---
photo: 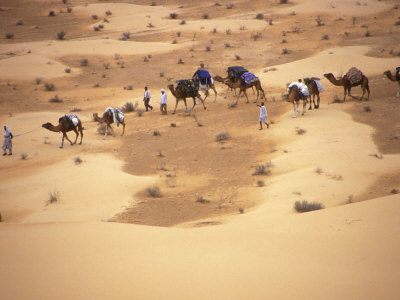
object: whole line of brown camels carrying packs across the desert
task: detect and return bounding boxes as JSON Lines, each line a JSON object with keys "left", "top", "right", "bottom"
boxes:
{"left": 38, "top": 66, "right": 400, "bottom": 148}
